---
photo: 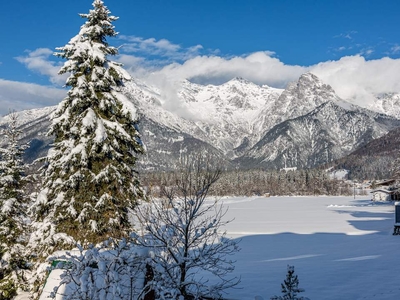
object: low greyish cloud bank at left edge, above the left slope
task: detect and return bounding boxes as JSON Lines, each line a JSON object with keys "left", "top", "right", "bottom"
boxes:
{"left": 0, "top": 79, "right": 66, "bottom": 116}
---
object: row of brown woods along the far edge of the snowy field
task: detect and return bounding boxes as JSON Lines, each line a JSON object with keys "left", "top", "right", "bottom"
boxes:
{"left": 140, "top": 169, "right": 354, "bottom": 197}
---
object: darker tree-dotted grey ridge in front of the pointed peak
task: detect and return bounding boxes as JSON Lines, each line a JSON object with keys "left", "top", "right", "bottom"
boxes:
{"left": 238, "top": 101, "right": 400, "bottom": 168}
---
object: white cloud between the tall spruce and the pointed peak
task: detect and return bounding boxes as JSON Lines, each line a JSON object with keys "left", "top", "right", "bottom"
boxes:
{"left": 124, "top": 51, "right": 307, "bottom": 119}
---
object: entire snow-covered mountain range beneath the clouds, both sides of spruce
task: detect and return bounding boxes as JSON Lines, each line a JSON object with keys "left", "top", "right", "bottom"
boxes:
{"left": 0, "top": 73, "right": 400, "bottom": 170}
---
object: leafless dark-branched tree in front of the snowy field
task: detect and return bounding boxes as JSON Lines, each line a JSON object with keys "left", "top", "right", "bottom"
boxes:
{"left": 134, "top": 154, "right": 239, "bottom": 299}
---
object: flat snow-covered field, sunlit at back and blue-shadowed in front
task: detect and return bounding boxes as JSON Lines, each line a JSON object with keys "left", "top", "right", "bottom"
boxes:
{"left": 217, "top": 196, "right": 400, "bottom": 300}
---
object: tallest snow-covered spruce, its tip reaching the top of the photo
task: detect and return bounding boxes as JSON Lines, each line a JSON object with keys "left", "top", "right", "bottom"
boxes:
{"left": 33, "top": 0, "right": 143, "bottom": 256}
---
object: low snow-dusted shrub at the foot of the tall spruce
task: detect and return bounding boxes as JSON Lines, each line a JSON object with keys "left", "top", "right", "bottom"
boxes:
{"left": 50, "top": 239, "right": 145, "bottom": 300}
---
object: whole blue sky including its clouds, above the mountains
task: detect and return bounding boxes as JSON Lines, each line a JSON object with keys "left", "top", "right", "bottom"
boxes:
{"left": 0, "top": 0, "right": 400, "bottom": 113}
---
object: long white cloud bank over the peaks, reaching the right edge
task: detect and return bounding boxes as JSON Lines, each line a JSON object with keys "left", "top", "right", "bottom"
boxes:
{"left": 135, "top": 52, "right": 400, "bottom": 114}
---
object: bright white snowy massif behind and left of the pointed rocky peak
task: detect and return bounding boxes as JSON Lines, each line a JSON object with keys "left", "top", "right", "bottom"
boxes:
{"left": 126, "top": 78, "right": 282, "bottom": 158}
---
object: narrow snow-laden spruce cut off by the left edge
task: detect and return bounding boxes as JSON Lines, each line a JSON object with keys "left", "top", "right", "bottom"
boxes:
{"left": 0, "top": 113, "right": 28, "bottom": 299}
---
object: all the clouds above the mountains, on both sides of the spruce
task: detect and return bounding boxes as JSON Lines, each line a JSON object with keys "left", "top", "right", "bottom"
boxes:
{"left": 0, "top": 36, "right": 400, "bottom": 115}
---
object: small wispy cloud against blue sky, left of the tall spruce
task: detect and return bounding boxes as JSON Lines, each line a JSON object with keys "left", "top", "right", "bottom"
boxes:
{"left": 15, "top": 48, "right": 68, "bottom": 85}
